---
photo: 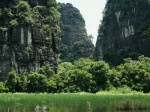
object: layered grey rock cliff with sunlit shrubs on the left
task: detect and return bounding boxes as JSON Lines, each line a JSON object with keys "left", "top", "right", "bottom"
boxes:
{"left": 0, "top": 0, "right": 60, "bottom": 80}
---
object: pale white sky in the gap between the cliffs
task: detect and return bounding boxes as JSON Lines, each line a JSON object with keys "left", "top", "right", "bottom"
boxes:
{"left": 56, "top": 0, "right": 106, "bottom": 44}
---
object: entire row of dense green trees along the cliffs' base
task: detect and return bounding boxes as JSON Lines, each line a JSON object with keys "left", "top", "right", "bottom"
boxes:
{"left": 0, "top": 56, "right": 150, "bottom": 93}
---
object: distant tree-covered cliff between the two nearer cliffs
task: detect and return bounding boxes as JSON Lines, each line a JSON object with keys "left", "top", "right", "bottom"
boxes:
{"left": 58, "top": 3, "right": 94, "bottom": 62}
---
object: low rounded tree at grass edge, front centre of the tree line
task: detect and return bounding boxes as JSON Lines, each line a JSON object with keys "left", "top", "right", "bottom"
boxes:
{"left": 68, "top": 69, "right": 96, "bottom": 92}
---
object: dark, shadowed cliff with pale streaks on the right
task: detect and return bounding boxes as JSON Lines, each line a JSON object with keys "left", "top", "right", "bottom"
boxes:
{"left": 94, "top": 0, "right": 150, "bottom": 64}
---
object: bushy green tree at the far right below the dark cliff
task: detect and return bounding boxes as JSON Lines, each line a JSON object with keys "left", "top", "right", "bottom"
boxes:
{"left": 117, "top": 56, "right": 150, "bottom": 92}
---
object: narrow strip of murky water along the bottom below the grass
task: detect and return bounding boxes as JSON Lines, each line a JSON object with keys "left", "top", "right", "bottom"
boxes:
{"left": 0, "top": 106, "right": 150, "bottom": 112}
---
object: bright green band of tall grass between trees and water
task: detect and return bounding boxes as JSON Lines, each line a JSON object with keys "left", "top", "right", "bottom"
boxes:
{"left": 0, "top": 93, "right": 150, "bottom": 112}
